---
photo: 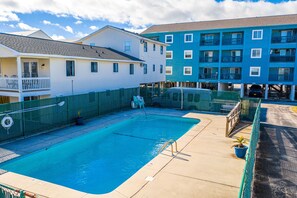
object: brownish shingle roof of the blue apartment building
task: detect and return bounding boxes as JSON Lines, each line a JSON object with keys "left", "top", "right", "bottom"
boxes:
{"left": 142, "top": 14, "right": 297, "bottom": 34}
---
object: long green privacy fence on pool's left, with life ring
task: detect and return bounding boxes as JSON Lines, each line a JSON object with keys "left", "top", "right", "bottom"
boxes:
{"left": 0, "top": 88, "right": 138, "bottom": 142}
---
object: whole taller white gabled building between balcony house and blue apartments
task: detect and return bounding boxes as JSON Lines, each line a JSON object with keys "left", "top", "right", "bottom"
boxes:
{"left": 77, "top": 26, "right": 167, "bottom": 84}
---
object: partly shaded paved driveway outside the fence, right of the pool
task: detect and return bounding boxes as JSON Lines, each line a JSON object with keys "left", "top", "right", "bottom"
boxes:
{"left": 253, "top": 104, "right": 297, "bottom": 198}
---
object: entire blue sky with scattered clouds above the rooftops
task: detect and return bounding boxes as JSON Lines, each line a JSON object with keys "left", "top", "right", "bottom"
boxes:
{"left": 0, "top": 0, "right": 297, "bottom": 39}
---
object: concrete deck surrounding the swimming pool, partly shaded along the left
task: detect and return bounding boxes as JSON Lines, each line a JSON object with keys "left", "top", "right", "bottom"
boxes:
{"left": 0, "top": 108, "right": 251, "bottom": 198}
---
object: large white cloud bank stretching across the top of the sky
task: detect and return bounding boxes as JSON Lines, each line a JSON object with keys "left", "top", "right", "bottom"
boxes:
{"left": 0, "top": 0, "right": 297, "bottom": 30}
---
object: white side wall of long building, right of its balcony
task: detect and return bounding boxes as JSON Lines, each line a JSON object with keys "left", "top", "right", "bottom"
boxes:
{"left": 50, "top": 58, "right": 142, "bottom": 97}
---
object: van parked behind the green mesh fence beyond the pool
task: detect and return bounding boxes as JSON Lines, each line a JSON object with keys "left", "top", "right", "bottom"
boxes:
{"left": 152, "top": 87, "right": 212, "bottom": 111}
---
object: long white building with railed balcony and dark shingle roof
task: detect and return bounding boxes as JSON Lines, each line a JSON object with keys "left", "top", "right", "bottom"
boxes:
{"left": 0, "top": 33, "right": 165, "bottom": 103}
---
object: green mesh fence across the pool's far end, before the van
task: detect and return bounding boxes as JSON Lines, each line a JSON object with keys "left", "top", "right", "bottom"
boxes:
{"left": 140, "top": 87, "right": 240, "bottom": 113}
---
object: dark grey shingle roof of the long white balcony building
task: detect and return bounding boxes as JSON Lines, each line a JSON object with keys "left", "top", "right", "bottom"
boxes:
{"left": 0, "top": 33, "right": 142, "bottom": 61}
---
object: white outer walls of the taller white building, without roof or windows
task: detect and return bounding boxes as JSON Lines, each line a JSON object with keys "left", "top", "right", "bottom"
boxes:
{"left": 83, "top": 28, "right": 166, "bottom": 83}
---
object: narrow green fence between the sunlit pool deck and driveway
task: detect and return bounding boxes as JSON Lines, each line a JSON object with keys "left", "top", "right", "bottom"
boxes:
{"left": 238, "top": 101, "right": 261, "bottom": 198}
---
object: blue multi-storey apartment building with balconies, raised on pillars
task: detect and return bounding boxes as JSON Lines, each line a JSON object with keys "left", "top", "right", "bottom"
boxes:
{"left": 142, "top": 14, "right": 297, "bottom": 100}
